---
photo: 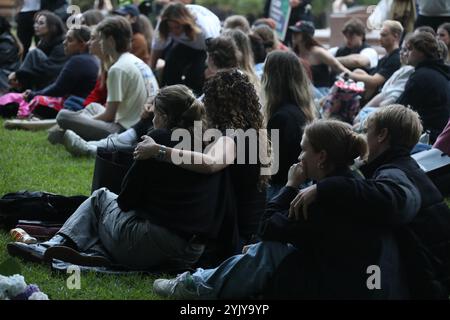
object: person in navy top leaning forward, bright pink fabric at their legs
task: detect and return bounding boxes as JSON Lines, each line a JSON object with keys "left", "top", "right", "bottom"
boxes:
{"left": 0, "top": 26, "right": 99, "bottom": 129}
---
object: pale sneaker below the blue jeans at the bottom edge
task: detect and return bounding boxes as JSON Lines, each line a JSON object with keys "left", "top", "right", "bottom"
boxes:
{"left": 153, "top": 271, "right": 200, "bottom": 300}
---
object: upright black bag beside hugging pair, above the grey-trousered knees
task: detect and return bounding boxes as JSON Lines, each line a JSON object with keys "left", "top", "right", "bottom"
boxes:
{"left": 92, "top": 148, "right": 134, "bottom": 194}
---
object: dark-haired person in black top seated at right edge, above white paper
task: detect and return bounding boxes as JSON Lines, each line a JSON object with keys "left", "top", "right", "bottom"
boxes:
{"left": 397, "top": 32, "right": 450, "bottom": 143}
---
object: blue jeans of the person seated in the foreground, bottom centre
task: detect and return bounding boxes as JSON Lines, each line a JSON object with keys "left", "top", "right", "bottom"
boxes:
{"left": 192, "top": 241, "right": 296, "bottom": 299}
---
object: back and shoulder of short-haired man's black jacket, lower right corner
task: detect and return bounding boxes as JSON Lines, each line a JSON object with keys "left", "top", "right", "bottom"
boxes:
{"left": 362, "top": 148, "right": 450, "bottom": 299}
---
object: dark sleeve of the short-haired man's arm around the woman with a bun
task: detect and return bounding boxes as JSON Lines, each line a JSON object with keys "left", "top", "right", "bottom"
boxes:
{"left": 317, "top": 168, "right": 421, "bottom": 225}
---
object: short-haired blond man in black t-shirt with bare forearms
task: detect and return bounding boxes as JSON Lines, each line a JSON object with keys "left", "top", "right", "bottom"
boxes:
{"left": 349, "top": 20, "right": 403, "bottom": 99}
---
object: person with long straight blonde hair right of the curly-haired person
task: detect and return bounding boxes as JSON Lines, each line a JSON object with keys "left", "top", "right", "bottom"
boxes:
{"left": 263, "top": 51, "right": 316, "bottom": 200}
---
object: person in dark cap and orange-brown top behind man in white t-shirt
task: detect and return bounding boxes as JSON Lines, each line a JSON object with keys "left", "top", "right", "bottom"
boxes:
{"left": 114, "top": 4, "right": 150, "bottom": 64}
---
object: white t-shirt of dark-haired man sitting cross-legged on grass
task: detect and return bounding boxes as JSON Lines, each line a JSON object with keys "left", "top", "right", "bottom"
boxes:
{"left": 106, "top": 52, "right": 158, "bottom": 129}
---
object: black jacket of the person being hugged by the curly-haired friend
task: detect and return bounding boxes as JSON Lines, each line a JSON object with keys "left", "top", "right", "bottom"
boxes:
{"left": 117, "top": 130, "right": 238, "bottom": 254}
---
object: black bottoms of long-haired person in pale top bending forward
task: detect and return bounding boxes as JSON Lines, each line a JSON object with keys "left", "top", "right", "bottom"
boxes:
{"left": 162, "top": 43, "right": 206, "bottom": 95}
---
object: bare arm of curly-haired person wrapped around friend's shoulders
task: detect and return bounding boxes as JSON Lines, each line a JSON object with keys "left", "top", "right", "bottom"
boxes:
{"left": 134, "top": 136, "right": 236, "bottom": 174}
